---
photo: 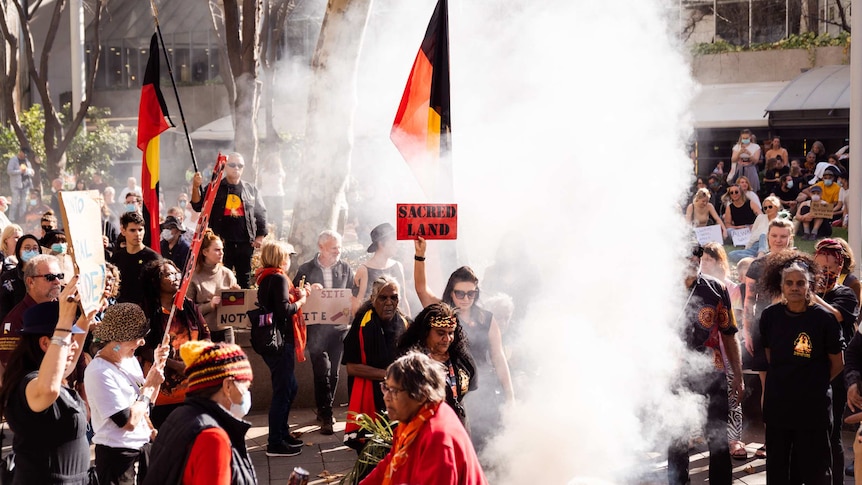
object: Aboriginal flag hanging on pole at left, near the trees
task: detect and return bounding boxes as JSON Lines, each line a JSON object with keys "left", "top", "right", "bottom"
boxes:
{"left": 138, "top": 34, "right": 170, "bottom": 246}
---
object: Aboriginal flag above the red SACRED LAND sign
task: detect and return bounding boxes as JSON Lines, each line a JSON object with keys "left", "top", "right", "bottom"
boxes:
{"left": 390, "top": 0, "right": 452, "bottom": 195}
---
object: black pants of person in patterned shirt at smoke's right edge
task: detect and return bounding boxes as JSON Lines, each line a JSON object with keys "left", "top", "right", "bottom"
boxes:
{"left": 667, "top": 372, "right": 728, "bottom": 485}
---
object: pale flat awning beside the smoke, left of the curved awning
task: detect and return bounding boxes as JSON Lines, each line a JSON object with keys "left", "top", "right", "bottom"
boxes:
{"left": 691, "top": 81, "right": 789, "bottom": 129}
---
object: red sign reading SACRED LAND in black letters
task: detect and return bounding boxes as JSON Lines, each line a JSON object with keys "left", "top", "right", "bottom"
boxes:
{"left": 395, "top": 204, "right": 458, "bottom": 239}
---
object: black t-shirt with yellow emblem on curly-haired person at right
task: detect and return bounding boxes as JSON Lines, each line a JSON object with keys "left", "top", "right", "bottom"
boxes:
{"left": 760, "top": 303, "right": 844, "bottom": 429}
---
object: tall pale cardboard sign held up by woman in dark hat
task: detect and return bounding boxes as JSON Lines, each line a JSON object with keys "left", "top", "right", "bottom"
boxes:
{"left": 59, "top": 190, "right": 106, "bottom": 314}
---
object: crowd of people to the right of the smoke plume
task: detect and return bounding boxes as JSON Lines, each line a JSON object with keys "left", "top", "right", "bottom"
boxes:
{"left": 680, "top": 130, "right": 862, "bottom": 484}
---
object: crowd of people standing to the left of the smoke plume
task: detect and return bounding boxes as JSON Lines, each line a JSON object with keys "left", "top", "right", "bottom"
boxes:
{"left": 0, "top": 148, "right": 515, "bottom": 484}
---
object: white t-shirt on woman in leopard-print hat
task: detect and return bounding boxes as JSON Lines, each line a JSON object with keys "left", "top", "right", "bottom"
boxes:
{"left": 84, "top": 357, "right": 150, "bottom": 450}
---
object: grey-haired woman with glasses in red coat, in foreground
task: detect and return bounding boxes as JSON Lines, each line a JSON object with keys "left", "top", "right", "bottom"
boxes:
{"left": 360, "top": 350, "right": 488, "bottom": 485}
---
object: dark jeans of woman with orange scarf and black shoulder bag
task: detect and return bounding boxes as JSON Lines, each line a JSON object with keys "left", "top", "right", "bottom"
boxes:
{"left": 262, "top": 341, "right": 299, "bottom": 446}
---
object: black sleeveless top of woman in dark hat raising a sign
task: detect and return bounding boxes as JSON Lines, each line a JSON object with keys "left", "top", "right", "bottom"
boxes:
{"left": 6, "top": 371, "right": 90, "bottom": 483}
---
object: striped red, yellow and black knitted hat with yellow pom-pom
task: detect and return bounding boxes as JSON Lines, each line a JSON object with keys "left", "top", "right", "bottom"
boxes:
{"left": 180, "top": 340, "right": 252, "bottom": 393}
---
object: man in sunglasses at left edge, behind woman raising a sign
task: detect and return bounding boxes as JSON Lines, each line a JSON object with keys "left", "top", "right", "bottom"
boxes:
{"left": 0, "top": 254, "right": 66, "bottom": 369}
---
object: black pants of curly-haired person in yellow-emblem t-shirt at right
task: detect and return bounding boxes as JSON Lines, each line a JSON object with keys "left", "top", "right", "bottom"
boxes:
{"left": 766, "top": 424, "right": 841, "bottom": 485}
